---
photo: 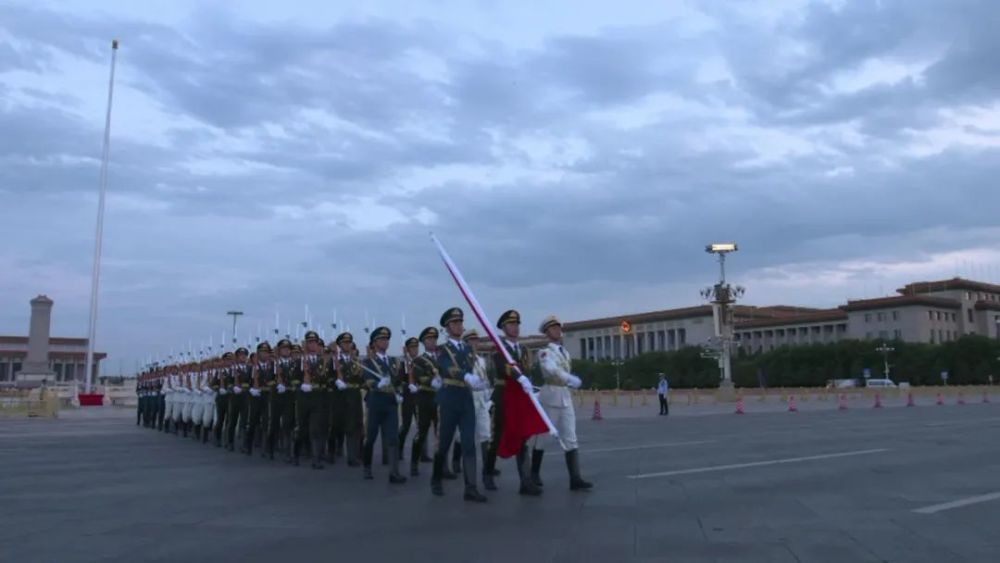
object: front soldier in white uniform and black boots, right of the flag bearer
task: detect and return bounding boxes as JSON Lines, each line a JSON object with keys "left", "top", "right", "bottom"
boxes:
{"left": 536, "top": 316, "right": 593, "bottom": 491}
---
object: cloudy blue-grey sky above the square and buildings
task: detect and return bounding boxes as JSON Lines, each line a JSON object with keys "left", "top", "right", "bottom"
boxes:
{"left": 0, "top": 0, "right": 1000, "bottom": 372}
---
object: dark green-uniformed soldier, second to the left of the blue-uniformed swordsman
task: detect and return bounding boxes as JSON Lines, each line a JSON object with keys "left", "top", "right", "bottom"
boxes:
{"left": 295, "top": 330, "right": 330, "bottom": 469}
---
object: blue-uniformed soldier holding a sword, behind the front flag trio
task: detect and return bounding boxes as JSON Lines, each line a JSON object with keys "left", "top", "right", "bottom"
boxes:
{"left": 364, "top": 326, "right": 406, "bottom": 484}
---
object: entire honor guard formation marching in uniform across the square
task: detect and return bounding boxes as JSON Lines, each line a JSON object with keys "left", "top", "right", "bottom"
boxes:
{"left": 129, "top": 307, "right": 592, "bottom": 502}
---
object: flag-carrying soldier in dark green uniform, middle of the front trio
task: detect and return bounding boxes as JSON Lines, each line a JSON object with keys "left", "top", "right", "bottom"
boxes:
{"left": 483, "top": 309, "right": 543, "bottom": 496}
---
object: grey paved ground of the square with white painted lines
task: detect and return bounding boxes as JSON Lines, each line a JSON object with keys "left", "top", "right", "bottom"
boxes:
{"left": 0, "top": 403, "right": 1000, "bottom": 563}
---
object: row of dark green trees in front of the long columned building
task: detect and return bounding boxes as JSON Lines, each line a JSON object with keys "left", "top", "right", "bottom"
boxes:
{"left": 573, "top": 335, "right": 1000, "bottom": 390}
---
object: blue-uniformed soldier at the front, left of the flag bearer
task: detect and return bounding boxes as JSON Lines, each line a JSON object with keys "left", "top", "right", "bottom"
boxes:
{"left": 431, "top": 307, "right": 486, "bottom": 502}
